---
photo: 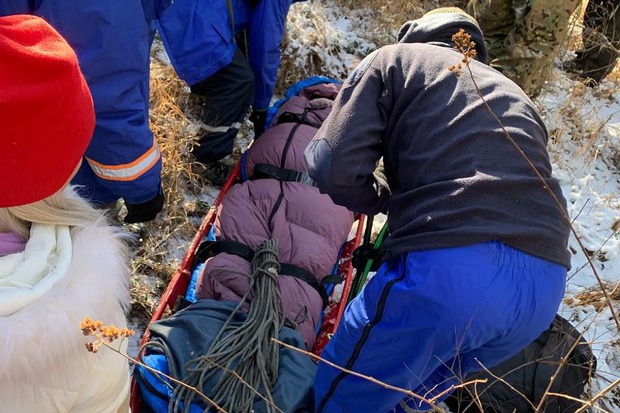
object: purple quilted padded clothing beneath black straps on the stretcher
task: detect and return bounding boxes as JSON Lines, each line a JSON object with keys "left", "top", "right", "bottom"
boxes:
{"left": 198, "top": 83, "right": 353, "bottom": 349}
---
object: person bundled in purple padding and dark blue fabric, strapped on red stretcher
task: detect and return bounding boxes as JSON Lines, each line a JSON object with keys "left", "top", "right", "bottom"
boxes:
{"left": 137, "top": 82, "right": 354, "bottom": 412}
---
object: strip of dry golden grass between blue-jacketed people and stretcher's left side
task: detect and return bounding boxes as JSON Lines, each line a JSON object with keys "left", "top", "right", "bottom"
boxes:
{"left": 128, "top": 52, "right": 208, "bottom": 322}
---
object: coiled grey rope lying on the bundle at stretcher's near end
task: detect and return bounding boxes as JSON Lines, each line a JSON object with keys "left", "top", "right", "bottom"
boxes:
{"left": 168, "top": 239, "right": 284, "bottom": 413}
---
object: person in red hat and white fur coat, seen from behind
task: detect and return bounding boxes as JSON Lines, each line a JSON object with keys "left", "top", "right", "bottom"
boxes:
{"left": 0, "top": 15, "right": 129, "bottom": 413}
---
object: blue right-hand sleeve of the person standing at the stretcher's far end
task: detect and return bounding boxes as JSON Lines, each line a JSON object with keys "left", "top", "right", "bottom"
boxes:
{"left": 248, "top": 0, "right": 293, "bottom": 109}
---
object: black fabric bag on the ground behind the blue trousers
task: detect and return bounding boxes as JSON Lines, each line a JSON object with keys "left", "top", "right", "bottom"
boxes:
{"left": 445, "top": 315, "right": 596, "bottom": 413}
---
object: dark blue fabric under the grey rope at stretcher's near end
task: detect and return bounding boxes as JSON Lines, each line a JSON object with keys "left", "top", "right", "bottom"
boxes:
{"left": 133, "top": 299, "right": 317, "bottom": 413}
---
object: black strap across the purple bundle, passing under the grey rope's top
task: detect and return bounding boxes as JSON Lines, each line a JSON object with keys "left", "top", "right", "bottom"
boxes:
{"left": 195, "top": 241, "right": 329, "bottom": 308}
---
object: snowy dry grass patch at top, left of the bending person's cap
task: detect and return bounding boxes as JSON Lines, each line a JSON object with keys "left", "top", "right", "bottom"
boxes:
{"left": 276, "top": 0, "right": 432, "bottom": 94}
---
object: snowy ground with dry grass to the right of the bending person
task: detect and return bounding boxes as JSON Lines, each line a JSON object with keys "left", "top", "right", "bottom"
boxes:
{"left": 537, "top": 70, "right": 620, "bottom": 412}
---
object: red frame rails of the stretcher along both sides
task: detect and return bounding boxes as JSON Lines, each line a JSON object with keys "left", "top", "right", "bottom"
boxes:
{"left": 130, "top": 162, "right": 366, "bottom": 413}
